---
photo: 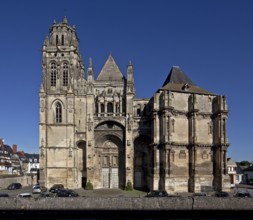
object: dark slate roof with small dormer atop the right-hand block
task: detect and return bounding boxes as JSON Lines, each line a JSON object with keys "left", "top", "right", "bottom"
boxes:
{"left": 162, "top": 66, "right": 213, "bottom": 94}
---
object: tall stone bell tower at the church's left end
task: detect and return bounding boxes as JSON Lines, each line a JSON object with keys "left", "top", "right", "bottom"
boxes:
{"left": 39, "top": 16, "right": 86, "bottom": 187}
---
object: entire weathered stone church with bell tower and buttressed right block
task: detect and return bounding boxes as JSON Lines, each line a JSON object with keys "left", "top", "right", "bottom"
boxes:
{"left": 39, "top": 17, "right": 229, "bottom": 193}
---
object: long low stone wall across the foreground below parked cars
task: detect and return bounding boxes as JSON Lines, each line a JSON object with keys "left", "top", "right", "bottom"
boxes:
{"left": 0, "top": 197, "right": 253, "bottom": 210}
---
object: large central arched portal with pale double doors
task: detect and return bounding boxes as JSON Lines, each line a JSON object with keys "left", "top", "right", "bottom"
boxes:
{"left": 95, "top": 121, "right": 125, "bottom": 189}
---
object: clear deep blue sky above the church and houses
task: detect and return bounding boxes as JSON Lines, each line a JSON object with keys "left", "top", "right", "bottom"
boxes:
{"left": 0, "top": 0, "right": 253, "bottom": 161}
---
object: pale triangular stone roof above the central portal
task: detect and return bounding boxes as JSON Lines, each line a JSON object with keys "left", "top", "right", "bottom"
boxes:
{"left": 97, "top": 54, "right": 124, "bottom": 81}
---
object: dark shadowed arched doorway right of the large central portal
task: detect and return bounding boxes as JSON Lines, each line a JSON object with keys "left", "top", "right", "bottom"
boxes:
{"left": 134, "top": 135, "right": 152, "bottom": 191}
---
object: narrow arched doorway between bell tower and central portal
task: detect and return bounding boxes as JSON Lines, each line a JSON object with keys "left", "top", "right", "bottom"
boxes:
{"left": 77, "top": 141, "right": 87, "bottom": 188}
